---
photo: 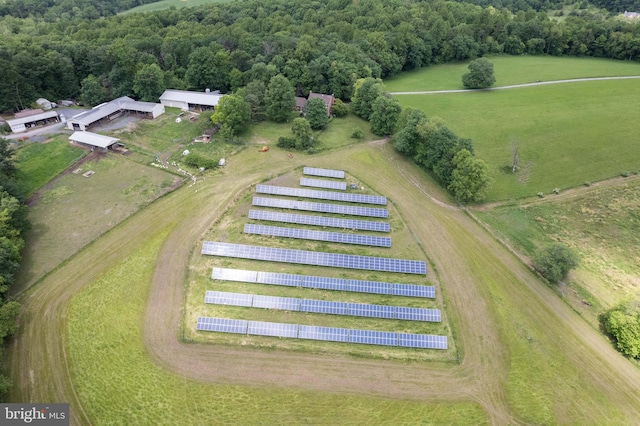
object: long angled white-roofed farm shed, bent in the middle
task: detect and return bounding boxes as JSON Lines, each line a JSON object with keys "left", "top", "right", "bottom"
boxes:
{"left": 67, "top": 96, "right": 164, "bottom": 130}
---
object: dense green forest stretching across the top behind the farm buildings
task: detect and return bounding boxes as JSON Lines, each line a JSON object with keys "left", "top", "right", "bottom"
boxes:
{"left": 0, "top": 0, "right": 640, "bottom": 112}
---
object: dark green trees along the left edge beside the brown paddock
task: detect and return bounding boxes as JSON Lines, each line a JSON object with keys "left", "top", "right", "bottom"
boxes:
{"left": 0, "top": 138, "right": 30, "bottom": 398}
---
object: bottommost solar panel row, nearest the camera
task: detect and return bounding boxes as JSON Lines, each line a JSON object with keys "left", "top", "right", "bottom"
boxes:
{"left": 196, "top": 317, "right": 448, "bottom": 349}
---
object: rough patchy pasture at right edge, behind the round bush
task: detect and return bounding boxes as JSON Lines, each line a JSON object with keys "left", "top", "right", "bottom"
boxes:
{"left": 476, "top": 176, "right": 640, "bottom": 327}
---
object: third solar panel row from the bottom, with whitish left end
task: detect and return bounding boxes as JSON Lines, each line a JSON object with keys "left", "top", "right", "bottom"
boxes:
{"left": 211, "top": 268, "right": 436, "bottom": 299}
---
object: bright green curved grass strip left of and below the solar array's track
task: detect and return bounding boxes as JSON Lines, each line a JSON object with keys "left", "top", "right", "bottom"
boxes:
{"left": 65, "top": 230, "right": 487, "bottom": 425}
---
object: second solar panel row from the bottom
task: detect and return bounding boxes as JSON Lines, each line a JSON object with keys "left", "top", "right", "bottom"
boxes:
{"left": 204, "top": 291, "right": 441, "bottom": 322}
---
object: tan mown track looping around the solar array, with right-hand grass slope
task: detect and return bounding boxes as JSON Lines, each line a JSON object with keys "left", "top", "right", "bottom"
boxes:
{"left": 8, "top": 144, "right": 640, "bottom": 424}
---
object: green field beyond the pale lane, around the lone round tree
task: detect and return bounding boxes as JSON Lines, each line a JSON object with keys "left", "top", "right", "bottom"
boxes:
{"left": 384, "top": 56, "right": 640, "bottom": 92}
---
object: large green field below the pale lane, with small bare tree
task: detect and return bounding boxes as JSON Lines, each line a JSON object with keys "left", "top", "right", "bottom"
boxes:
{"left": 397, "top": 80, "right": 640, "bottom": 201}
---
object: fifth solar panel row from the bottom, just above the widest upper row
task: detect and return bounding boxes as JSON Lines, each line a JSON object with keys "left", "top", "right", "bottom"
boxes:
{"left": 244, "top": 223, "right": 391, "bottom": 247}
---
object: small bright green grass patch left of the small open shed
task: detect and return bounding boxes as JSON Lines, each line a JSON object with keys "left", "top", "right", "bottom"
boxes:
{"left": 15, "top": 135, "right": 87, "bottom": 197}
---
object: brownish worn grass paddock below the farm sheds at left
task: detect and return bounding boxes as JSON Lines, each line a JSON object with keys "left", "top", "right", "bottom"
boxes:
{"left": 11, "top": 154, "right": 177, "bottom": 294}
